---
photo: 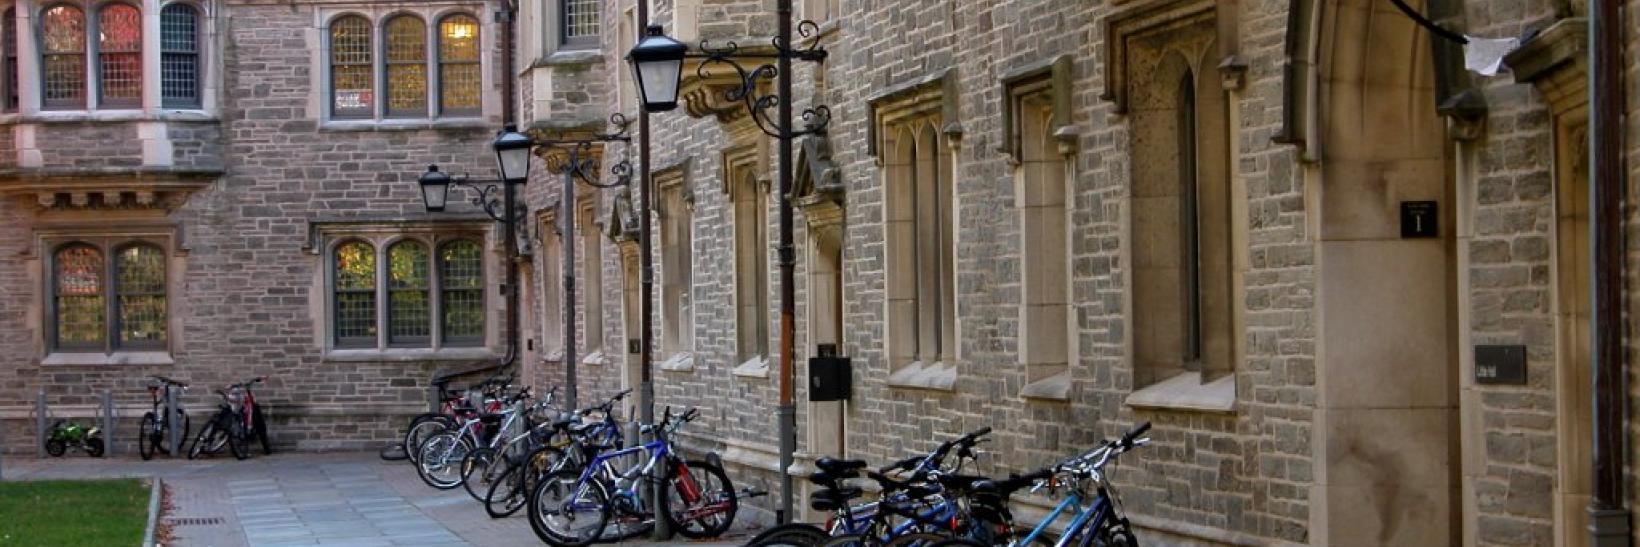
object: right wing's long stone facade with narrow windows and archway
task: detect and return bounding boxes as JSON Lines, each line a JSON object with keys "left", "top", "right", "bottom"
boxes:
{"left": 523, "top": 0, "right": 1640, "bottom": 545}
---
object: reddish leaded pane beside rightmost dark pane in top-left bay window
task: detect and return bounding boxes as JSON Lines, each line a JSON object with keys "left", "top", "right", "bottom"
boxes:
{"left": 97, "top": 3, "right": 143, "bottom": 106}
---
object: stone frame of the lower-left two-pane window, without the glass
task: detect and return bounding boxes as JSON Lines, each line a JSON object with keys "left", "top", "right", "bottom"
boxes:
{"left": 41, "top": 234, "right": 175, "bottom": 355}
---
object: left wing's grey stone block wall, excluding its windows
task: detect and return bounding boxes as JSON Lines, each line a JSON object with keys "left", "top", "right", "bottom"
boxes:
{"left": 0, "top": 2, "right": 507, "bottom": 452}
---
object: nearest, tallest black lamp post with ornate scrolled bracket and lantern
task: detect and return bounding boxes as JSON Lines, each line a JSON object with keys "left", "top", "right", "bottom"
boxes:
{"left": 626, "top": 0, "right": 831, "bottom": 522}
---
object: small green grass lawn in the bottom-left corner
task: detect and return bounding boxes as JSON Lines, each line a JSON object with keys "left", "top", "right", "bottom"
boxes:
{"left": 0, "top": 478, "right": 149, "bottom": 547}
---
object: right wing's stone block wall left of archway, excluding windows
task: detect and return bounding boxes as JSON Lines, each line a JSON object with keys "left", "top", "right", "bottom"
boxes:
{"left": 524, "top": 2, "right": 1315, "bottom": 542}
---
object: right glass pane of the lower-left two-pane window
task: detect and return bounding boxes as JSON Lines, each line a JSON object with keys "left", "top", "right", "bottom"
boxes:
{"left": 115, "top": 244, "right": 166, "bottom": 347}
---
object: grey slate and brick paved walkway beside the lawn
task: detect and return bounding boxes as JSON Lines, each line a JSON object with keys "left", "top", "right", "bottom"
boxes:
{"left": 3, "top": 452, "right": 748, "bottom": 547}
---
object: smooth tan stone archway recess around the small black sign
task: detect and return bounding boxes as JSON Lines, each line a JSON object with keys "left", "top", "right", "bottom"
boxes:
{"left": 1305, "top": 0, "right": 1461, "bottom": 545}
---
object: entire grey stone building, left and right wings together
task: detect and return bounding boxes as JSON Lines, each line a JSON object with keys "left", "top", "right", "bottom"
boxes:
{"left": 0, "top": 0, "right": 1640, "bottom": 545}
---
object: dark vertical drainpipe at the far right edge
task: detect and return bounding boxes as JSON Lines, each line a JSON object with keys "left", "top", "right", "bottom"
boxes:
{"left": 1588, "top": 0, "right": 1630, "bottom": 547}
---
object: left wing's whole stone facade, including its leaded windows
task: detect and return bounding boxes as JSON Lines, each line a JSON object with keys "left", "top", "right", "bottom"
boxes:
{"left": 0, "top": 0, "right": 507, "bottom": 445}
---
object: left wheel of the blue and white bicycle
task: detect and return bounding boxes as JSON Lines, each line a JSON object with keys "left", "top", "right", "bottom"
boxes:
{"left": 528, "top": 472, "right": 610, "bottom": 547}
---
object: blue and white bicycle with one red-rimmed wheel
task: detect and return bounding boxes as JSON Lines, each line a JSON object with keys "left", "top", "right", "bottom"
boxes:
{"left": 528, "top": 408, "right": 738, "bottom": 547}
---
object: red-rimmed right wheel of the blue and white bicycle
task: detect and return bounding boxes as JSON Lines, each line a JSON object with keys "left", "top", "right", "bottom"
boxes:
{"left": 661, "top": 460, "right": 740, "bottom": 539}
